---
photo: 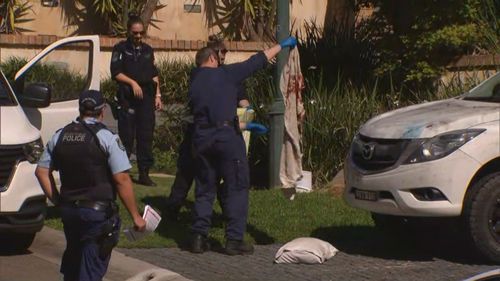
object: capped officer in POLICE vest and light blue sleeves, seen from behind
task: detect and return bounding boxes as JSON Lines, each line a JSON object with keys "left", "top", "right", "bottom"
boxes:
{"left": 35, "top": 90, "right": 146, "bottom": 281}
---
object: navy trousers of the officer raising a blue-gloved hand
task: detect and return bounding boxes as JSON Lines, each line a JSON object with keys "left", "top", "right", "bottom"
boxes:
{"left": 191, "top": 129, "right": 250, "bottom": 240}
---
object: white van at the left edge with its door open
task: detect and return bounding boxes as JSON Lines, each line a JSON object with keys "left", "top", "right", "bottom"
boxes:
{"left": 0, "top": 36, "right": 100, "bottom": 250}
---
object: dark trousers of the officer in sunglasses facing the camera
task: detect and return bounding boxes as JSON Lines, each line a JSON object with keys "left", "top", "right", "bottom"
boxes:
{"left": 118, "top": 83, "right": 155, "bottom": 171}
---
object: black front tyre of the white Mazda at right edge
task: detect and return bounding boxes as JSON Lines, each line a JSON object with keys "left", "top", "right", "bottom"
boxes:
{"left": 462, "top": 173, "right": 500, "bottom": 262}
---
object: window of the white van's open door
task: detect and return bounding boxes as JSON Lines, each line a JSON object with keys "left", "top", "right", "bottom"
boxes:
{"left": 16, "top": 41, "right": 92, "bottom": 102}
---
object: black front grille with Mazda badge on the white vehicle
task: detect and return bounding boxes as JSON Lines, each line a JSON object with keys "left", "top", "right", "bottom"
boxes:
{"left": 351, "top": 135, "right": 410, "bottom": 172}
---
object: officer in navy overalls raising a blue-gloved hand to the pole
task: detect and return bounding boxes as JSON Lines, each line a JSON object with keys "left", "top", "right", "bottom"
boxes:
{"left": 189, "top": 37, "right": 297, "bottom": 255}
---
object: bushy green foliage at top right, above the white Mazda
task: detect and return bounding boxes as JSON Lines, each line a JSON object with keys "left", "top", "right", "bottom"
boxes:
{"left": 359, "top": 0, "right": 498, "bottom": 90}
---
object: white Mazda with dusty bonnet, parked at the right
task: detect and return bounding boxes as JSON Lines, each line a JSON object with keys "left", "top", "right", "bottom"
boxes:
{"left": 344, "top": 73, "right": 500, "bottom": 262}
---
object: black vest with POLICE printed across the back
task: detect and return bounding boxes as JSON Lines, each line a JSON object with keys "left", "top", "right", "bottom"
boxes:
{"left": 52, "top": 123, "right": 116, "bottom": 202}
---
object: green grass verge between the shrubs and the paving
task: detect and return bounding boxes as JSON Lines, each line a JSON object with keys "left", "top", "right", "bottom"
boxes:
{"left": 46, "top": 174, "right": 373, "bottom": 248}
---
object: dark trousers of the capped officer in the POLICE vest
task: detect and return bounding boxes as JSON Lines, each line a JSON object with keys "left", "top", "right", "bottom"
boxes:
{"left": 61, "top": 207, "right": 120, "bottom": 281}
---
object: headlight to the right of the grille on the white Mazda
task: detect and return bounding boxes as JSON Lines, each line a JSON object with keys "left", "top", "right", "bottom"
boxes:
{"left": 404, "top": 129, "right": 486, "bottom": 164}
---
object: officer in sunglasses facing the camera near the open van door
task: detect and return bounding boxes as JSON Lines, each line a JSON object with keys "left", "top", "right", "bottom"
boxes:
{"left": 110, "top": 12, "right": 162, "bottom": 186}
